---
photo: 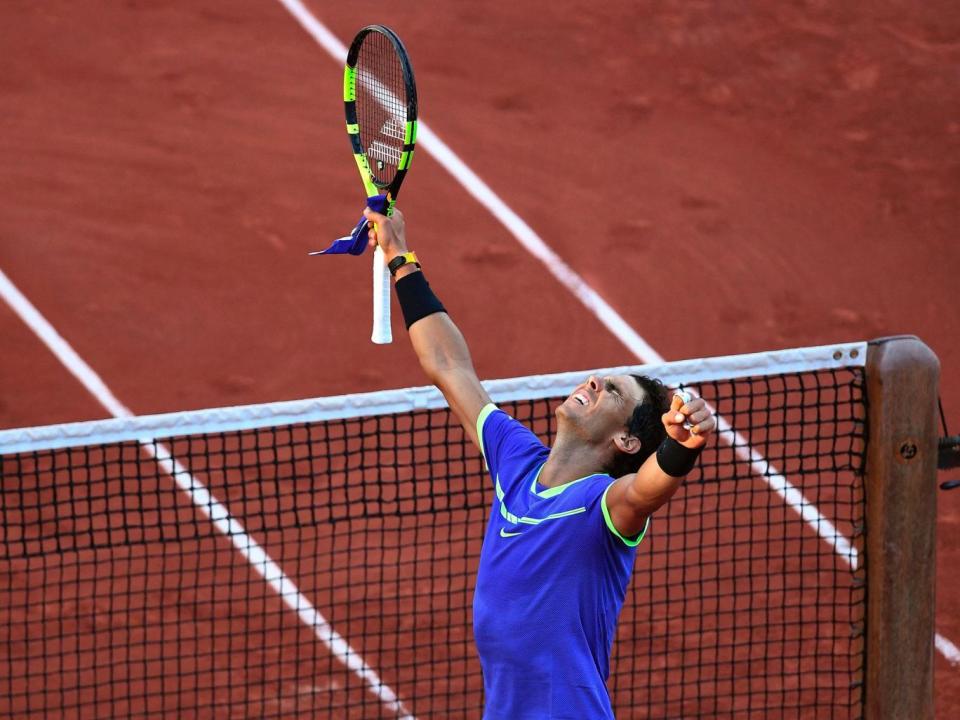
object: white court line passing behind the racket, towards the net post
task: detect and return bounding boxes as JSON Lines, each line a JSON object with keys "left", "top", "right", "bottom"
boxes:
{"left": 277, "top": 0, "right": 960, "bottom": 665}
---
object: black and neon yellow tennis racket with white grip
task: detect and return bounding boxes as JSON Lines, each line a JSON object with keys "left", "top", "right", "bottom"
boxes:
{"left": 343, "top": 25, "right": 417, "bottom": 344}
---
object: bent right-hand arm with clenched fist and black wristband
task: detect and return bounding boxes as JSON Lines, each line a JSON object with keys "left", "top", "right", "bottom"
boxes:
{"left": 606, "top": 395, "right": 717, "bottom": 537}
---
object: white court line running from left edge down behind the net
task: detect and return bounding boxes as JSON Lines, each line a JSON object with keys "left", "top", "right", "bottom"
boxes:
{"left": 0, "top": 268, "right": 416, "bottom": 720}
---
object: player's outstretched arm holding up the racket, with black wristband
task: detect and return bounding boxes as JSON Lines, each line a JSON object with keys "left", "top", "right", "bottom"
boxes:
{"left": 364, "top": 208, "right": 490, "bottom": 447}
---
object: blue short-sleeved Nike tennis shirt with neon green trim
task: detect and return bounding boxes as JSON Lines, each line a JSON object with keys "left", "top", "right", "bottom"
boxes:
{"left": 473, "top": 404, "right": 649, "bottom": 720}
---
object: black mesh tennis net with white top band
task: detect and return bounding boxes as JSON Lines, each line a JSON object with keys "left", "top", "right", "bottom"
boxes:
{"left": 0, "top": 343, "right": 880, "bottom": 719}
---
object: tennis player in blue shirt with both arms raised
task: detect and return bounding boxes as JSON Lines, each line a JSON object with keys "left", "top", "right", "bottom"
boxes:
{"left": 365, "top": 208, "right": 716, "bottom": 720}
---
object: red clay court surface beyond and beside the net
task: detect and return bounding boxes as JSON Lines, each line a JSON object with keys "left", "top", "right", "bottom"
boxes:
{"left": 0, "top": 0, "right": 960, "bottom": 718}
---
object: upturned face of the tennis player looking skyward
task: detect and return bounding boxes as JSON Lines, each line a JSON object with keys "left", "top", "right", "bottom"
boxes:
{"left": 557, "top": 375, "right": 643, "bottom": 438}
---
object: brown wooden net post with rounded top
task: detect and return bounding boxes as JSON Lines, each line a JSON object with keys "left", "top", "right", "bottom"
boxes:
{"left": 864, "top": 336, "right": 940, "bottom": 720}
